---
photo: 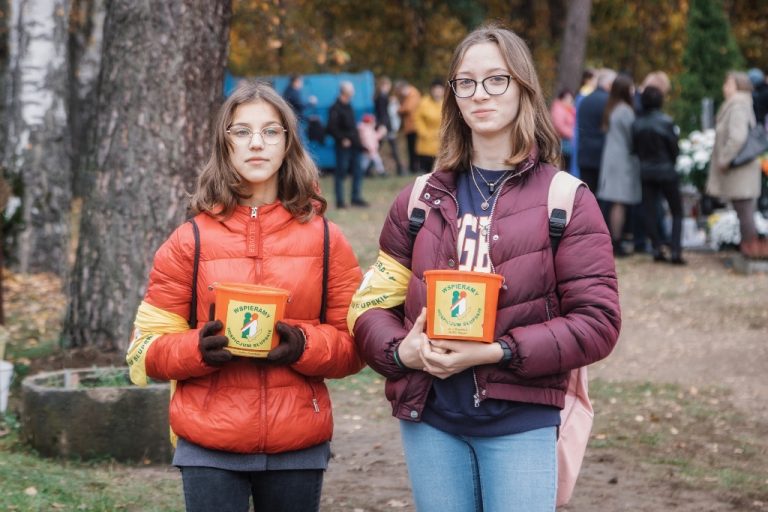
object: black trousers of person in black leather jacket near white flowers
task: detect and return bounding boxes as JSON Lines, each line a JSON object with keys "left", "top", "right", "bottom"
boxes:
{"left": 643, "top": 180, "right": 683, "bottom": 258}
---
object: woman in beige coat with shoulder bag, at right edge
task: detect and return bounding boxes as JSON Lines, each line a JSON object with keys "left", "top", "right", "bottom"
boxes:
{"left": 707, "top": 71, "right": 768, "bottom": 258}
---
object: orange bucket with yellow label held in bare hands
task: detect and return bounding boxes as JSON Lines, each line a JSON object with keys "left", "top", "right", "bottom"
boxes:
{"left": 424, "top": 270, "right": 504, "bottom": 343}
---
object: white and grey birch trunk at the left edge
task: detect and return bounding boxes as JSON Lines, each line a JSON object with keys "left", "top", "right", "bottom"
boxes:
{"left": 5, "top": 0, "right": 72, "bottom": 276}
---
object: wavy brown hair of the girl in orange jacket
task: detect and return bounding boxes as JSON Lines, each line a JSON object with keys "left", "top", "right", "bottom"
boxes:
{"left": 190, "top": 80, "right": 328, "bottom": 222}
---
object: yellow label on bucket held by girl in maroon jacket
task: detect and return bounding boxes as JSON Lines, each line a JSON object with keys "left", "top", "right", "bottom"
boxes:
{"left": 434, "top": 281, "right": 486, "bottom": 338}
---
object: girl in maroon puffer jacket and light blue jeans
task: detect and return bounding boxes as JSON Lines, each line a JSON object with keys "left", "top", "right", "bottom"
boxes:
{"left": 348, "top": 26, "right": 621, "bottom": 512}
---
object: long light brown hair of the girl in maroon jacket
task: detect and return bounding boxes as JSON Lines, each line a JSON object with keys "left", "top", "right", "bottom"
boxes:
{"left": 437, "top": 25, "right": 560, "bottom": 171}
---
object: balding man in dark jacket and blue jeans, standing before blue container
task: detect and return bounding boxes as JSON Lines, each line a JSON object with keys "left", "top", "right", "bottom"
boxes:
{"left": 327, "top": 81, "right": 368, "bottom": 208}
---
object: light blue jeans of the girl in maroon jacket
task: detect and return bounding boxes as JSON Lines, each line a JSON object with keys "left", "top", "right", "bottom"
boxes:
{"left": 400, "top": 421, "right": 557, "bottom": 512}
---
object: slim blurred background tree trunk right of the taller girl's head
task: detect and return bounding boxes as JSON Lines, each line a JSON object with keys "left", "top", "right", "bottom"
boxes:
{"left": 555, "top": 0, "right": 592, "bottom": 94}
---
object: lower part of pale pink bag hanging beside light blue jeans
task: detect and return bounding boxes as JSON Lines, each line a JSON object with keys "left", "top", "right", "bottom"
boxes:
{"left": 557, "top": 366, "right": 595, "bottom": 507}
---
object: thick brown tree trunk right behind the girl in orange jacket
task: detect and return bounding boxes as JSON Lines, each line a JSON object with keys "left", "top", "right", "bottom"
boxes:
{"left": 65, "top": 0, "right": 230, "bottom": 350}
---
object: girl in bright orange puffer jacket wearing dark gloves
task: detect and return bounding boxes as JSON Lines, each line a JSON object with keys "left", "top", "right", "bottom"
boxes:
{"left": 127, "top": 82, "right": 362, "bottom": 512}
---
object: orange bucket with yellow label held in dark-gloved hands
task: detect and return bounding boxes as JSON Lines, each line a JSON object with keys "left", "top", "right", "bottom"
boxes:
{"left": 213, "top": 283, "right": 288, "bottom": 357}
